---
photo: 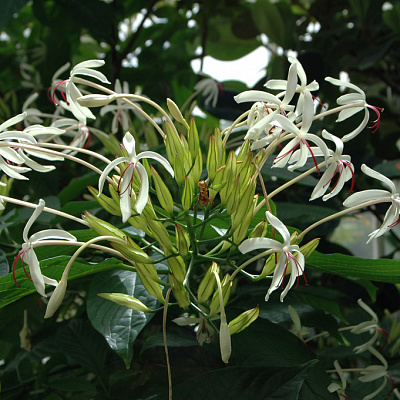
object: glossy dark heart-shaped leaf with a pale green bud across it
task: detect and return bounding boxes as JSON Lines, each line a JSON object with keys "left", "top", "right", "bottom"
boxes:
{"left": 87, "top": 270, "right": 158, "bottom": 368}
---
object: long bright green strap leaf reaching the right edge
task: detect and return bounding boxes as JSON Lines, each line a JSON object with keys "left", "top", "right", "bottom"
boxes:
{"left": 307, "top": 251, "right": 400, "bottom": 283}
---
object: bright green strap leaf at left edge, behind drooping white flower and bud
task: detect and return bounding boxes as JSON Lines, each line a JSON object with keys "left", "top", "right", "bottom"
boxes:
{"left": 0, "top": 256, "right": 126, "bottom": 308}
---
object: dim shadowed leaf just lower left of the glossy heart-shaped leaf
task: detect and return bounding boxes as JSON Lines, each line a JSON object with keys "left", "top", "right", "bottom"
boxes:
{"left": 55, "top": 319, "right": 107, "bottom": 375}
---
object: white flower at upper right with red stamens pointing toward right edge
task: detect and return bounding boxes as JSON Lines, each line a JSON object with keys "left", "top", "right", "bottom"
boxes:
{"left": 325, "top": 77, "right": 383, "bottom": 142}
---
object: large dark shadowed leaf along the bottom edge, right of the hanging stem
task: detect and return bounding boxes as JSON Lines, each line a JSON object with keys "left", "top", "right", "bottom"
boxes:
{"left": 174, "top": 360, "right": 318, "bottom": 400}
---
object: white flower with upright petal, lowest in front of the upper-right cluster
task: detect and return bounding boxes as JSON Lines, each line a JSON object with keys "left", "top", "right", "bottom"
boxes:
{"left": 273, "top": 90, "right": 329, "bottom": 171}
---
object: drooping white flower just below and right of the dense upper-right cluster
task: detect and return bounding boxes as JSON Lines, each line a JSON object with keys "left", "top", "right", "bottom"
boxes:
{"left": 308, "top": 129, "right": 354, "bottom": 201}
